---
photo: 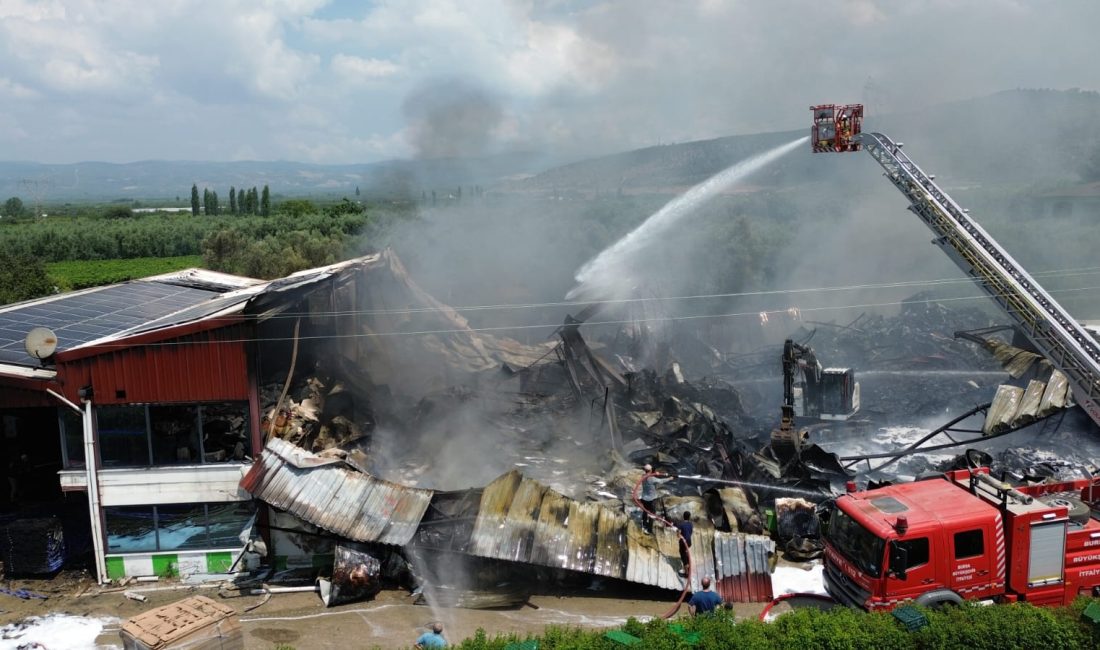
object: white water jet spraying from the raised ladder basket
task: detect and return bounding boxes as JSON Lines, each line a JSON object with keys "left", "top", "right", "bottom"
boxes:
{"left": 565, "top": 137, "right": 809, "bottom": 300}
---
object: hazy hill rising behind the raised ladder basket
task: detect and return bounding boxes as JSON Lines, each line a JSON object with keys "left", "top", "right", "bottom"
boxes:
{"left": 507, "top": 90, "right": 1100, "bottom": 192}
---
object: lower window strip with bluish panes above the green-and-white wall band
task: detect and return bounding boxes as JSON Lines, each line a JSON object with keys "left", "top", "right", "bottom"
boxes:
{"left": 103, "top": 502, "right": 256, "bottom": 553}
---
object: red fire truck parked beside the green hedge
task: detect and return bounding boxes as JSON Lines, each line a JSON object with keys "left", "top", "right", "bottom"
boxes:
{"left": 825, "top": 467, "right": 1100, "bottom": 610}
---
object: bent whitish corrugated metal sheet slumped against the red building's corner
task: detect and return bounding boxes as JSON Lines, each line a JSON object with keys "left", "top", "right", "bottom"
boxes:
{"left": 241, "top": 438, "right": 433, "bottom": 546}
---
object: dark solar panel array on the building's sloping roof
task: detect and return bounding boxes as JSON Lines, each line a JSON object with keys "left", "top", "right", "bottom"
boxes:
{"left": 0, "top": 282, "right": 221, "bottom": 366}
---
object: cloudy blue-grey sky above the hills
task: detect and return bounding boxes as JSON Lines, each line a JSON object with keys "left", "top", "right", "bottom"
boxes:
{"left": 0, "top": 0, "right": 1100, "bottom": 164}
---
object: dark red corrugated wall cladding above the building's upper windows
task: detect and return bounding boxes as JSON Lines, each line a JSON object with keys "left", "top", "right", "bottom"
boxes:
{"left": 57, "top": 324, "right": 251, "bottom": 405}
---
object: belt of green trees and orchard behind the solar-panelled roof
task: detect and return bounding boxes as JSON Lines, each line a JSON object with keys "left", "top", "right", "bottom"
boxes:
{"left": 0, "top": 197, "right": 411, "bottom": 305}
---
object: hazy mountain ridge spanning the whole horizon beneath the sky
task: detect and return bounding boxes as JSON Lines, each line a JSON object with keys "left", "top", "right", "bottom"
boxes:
{"left": 0, "top": 90, "right": 1100, "bottom": 202}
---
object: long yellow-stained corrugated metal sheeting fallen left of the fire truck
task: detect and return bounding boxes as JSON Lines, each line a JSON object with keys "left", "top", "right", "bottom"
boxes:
{"left": 470, "top": 472, "right": 776, "bottom": 602}
